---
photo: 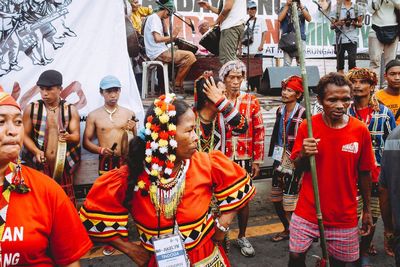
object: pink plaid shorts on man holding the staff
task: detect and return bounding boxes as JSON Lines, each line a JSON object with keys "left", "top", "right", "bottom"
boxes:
{"left": 289, "top": 214, "right": 360, "bottom": 262}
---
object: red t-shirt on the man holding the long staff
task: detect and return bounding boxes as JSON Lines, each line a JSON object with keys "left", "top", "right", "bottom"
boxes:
{"left": 291, "top": 114, "right": 375, "bottom": 228}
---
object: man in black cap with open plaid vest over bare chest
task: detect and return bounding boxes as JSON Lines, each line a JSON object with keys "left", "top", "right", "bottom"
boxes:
{"left": 23, "top": 70, "right": 80, "bottom": 203}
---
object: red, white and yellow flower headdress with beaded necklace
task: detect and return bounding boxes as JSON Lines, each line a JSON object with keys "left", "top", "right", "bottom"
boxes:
{"left": 141, "top": 94, "right": 189, "bottom": 219}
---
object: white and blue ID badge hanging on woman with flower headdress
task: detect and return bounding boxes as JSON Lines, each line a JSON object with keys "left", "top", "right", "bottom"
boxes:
{"left": 152, "top": 233, "right": 190, "bottom": 267}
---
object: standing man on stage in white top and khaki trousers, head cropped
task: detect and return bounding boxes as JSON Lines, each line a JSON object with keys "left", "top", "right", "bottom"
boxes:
{"left": 198, "top": 0, "right": 246, "bottom": 65}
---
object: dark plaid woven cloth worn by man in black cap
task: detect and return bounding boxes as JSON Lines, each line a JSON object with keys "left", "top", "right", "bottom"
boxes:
{"left": 22, "top": 100, "right": 81, "bottom": 174}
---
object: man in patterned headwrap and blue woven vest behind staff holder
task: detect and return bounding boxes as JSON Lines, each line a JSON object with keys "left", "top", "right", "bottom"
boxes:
{"left": 347, "top": 68, "right": 396, "bottom": 265}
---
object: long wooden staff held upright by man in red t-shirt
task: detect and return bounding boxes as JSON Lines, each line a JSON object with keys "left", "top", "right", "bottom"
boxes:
{"left": 292, "top": 1, "right": 330, "bottom": 267}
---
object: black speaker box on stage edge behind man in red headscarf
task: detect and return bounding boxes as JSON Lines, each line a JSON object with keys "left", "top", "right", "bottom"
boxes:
{"left": 258, "top": 66, "right": 320, "bottom": 96}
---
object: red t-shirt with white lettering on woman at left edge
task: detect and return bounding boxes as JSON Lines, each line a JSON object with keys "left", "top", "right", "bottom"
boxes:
{"left": 0, "top": 166, "right": 92, "bottom": 267}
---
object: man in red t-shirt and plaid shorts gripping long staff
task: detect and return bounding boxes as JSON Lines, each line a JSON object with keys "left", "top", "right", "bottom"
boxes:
{"left": 289, "top": 73, "right": 375, "bottom": 267}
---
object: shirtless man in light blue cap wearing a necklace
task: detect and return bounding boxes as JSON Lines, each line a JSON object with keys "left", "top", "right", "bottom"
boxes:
{"left": 83, "top": 75, "right": 136, "bottom": 175}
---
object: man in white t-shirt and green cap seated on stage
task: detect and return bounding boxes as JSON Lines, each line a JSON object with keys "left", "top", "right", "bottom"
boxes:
{"left": 144, "top": 0, "right": 196, "bottom": 90}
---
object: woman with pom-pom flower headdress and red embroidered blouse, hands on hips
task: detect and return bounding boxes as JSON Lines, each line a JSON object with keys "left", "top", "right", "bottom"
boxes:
{"left": 81, "top": 95, "right": 255, "bottom": 266}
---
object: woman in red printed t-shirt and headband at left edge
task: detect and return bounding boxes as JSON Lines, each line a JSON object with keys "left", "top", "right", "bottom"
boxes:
{"left": 0, "top": 87, "right": 92, "bottom": 267}
